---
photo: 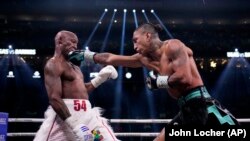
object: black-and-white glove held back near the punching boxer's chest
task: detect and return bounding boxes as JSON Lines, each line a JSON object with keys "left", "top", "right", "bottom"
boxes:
{"left": 146, "top": 72, "right": 169, "bottom": 89}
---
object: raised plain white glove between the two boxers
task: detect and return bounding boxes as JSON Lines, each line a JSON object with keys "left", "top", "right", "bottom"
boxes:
{"left": 91, "top": 65, "right": 118, "bottom": 88}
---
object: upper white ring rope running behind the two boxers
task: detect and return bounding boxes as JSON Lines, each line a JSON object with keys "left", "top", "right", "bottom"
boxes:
{"left": 8, "top": 118, "right": 250, "bottom": 123}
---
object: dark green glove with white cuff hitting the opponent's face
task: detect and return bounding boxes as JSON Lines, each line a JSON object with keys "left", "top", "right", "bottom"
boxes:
{"left": 68, "top": 50, "right": 96, "bottom": 66}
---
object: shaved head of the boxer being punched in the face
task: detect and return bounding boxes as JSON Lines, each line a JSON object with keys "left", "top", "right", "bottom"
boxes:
{"left": 55, "top": 30, "right": 78, "bottom": 56}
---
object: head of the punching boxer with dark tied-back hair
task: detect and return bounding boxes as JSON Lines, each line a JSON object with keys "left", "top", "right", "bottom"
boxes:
{"left": 133, "top": 23, "right": 162, "bottom": 55}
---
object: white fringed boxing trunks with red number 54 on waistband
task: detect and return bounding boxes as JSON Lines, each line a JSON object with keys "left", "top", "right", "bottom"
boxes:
{"left": 34, "top": 99, "right": 119, "bottom": 141}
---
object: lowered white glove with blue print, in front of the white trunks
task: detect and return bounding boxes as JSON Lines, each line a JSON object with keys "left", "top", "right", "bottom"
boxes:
{"left": 64, "top": 116, "right": 93, "bottom": 141}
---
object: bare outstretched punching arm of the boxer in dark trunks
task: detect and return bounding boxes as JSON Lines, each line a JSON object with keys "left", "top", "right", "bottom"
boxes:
{"left": 94, "top": 53, "right": 142, "bottom": 68}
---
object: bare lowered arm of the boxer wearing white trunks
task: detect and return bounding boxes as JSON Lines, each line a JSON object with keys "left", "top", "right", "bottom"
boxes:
{"left": 44, "top": 60, "right": 70, "bottom": 120}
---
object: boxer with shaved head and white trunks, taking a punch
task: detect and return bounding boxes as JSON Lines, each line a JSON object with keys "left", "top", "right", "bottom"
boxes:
{"left": 34, "top": 30, "right": 118, "bottom": 141}
